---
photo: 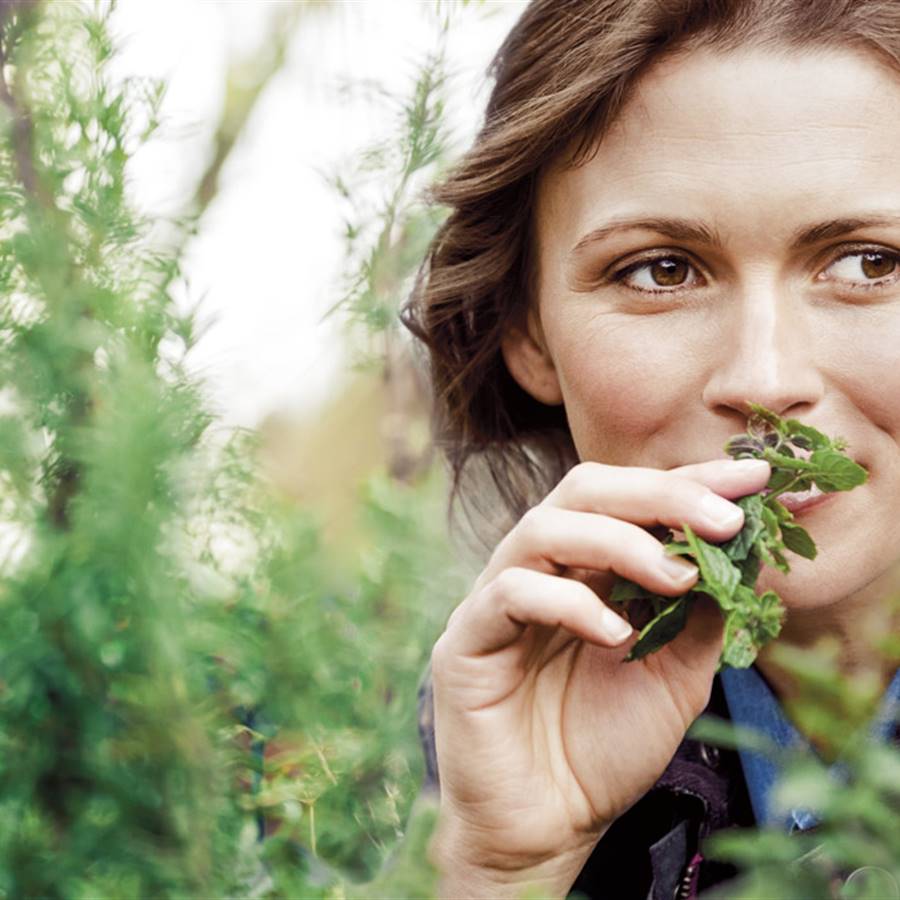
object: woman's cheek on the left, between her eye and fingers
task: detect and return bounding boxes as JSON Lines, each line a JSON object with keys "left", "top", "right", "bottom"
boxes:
{"left": 556, "top": 316, "right": 700, "bottom": 465}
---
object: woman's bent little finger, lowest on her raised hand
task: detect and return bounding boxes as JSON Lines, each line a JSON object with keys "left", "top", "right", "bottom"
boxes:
{"left": 435, "top": 568, "right": 632, "bottom": 656}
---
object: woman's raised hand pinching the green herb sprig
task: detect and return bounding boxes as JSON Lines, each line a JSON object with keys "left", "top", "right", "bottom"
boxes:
{"left": 432, "top": 460, "right": 769, "bottom": 896}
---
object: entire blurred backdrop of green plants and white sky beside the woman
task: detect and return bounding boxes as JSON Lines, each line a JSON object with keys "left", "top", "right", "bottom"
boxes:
{"left": 0, "top": 0, "right": 522, "bottom": 900}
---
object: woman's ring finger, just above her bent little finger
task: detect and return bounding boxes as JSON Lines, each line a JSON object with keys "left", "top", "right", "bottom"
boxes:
{"left": 491, "top": 506, "right": 698, "bottom": 597}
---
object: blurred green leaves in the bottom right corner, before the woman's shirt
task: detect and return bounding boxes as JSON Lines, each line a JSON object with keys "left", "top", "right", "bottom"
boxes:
{"left": 691, "top": 644, "right": 900, "bottom": 900}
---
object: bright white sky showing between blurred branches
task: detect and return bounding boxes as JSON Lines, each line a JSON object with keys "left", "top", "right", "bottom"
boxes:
{"left": 103, "top": 0, "right": 523, "bottom": 426}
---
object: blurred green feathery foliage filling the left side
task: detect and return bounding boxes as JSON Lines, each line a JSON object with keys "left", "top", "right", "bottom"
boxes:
{"left": 0, "top": 3, "right": 462, "bottom": 898}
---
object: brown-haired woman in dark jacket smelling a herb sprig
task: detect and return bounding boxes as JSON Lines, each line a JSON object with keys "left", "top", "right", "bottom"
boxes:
{"left": 405, "top": 0, "right": 900, "bottom": 898}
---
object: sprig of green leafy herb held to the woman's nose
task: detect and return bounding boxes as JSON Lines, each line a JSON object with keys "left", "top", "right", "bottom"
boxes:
{"left": 610, "top": 403, "right": 867, "bottom": 668}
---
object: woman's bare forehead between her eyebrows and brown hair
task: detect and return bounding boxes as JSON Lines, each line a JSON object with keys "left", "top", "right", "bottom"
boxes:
{"left": 536, "top": 49, "right": 900, "bottom": 249}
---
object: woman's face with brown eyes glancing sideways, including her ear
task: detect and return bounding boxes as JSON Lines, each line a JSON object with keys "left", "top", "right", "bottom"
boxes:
{"left": 504, "top": 50, "right": 900, "bottom": 608}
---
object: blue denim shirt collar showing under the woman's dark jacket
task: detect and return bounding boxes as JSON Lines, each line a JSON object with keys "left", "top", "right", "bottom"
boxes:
{"left": 720, "top": 666, "right": 900, "bottom": 832}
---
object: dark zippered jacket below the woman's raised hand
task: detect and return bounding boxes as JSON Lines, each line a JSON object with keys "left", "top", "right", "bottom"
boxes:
{"left": 419, "top": 677, "right": 754, "bottom": 900}
